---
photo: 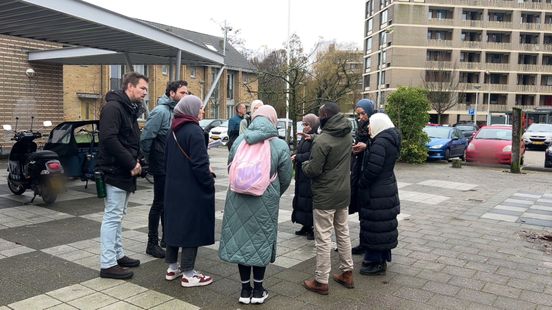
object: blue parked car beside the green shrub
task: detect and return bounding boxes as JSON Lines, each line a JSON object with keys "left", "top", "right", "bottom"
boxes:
{"left": 423, "top": 126, "right": 468, "bottom": 160}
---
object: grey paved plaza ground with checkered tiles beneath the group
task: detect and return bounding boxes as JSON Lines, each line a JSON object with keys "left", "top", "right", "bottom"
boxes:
{"left": 0, "top": 148, "right": 552, "bottom": 310}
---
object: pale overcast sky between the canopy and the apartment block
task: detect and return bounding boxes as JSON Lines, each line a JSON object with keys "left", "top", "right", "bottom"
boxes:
{"left": 85, "top": 0, "right": 364, "bottom": 51}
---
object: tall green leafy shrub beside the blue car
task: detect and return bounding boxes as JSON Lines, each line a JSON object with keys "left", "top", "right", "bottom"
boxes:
{"left": 385, "top": 87, "right": 431, "bottom": 164}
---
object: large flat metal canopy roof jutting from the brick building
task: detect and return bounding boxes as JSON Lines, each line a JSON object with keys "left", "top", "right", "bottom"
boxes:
{"left": 0, "top": 0, "right": 224, "bottom": 64}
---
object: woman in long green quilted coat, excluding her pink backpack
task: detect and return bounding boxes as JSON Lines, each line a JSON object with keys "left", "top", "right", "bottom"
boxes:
{"left": 219, "top": 105, "right": 292, "bottom": 304}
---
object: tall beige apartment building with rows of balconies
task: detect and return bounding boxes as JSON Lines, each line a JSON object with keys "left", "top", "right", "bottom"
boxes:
{"left": 363, "top": 0, "right": 552, "bottom": 124}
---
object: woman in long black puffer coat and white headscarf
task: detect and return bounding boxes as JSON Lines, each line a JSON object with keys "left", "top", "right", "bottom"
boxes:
{"left": 359, "top": 113, "right": 401, "bottom": 275}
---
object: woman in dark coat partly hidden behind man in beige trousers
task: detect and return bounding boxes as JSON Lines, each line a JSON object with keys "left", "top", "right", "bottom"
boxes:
{"left": 291, "top": 114, "right": 320, "bottom": 240}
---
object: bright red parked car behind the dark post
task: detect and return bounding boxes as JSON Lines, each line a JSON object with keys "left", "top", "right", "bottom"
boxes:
{"left": 466, "top": 126, "right": 525, "bottom": 165}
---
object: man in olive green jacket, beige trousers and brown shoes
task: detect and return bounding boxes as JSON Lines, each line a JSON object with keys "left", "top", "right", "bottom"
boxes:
{"left": 303, "top": 102, "right": 354, "bottom": 295}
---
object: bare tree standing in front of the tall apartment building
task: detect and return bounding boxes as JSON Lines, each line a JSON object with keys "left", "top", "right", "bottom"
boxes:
{"left": 422, "top": 59, "right": 464, "bottom": 124}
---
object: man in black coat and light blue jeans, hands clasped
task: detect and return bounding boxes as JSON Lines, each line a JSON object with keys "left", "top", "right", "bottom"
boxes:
{"left": 97, "top": 72, "right": 148, "bottom": 279}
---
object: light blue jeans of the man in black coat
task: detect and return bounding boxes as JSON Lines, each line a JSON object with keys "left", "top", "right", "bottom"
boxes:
{"left": 100, "top": 184, "right": 130, "bottom": 269}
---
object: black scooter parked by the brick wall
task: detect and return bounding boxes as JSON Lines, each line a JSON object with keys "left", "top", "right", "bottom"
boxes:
{"left": 3, "top": 116, "right": 65, "bottom": 204}
